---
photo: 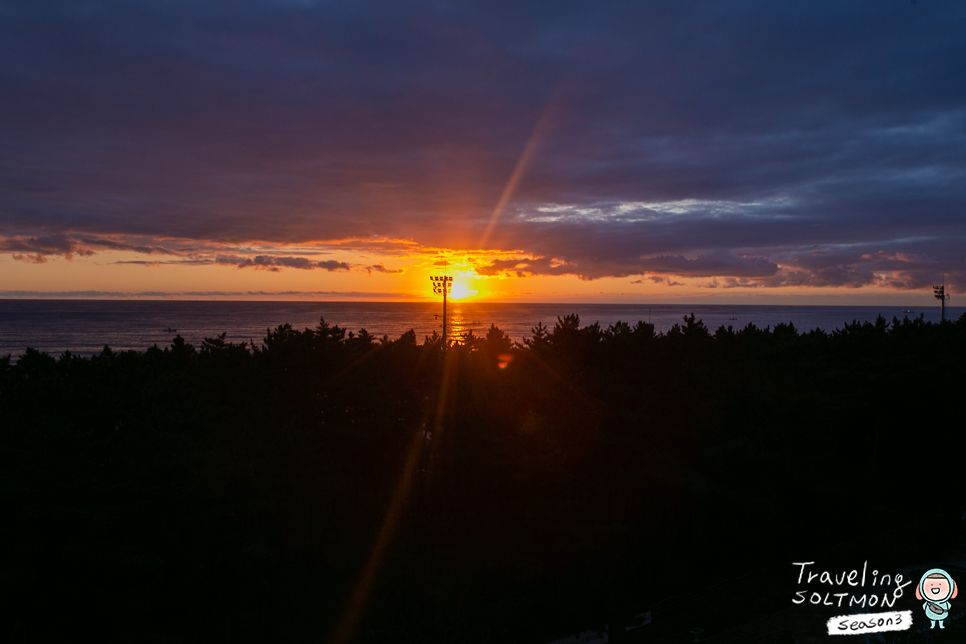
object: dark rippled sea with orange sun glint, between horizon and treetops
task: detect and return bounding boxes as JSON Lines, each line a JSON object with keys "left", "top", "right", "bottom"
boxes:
{"left": 0, "top": 300, "right": 966, "bottom": 358}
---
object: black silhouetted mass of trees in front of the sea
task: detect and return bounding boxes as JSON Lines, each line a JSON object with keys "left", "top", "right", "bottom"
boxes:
{"left": 0, "top": 316, "right": 966, "bottom": 644}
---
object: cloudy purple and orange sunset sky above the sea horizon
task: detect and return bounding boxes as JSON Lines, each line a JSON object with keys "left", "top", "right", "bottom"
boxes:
{"left": 0, "top": 0, "right": 966, "bottom": 305}
